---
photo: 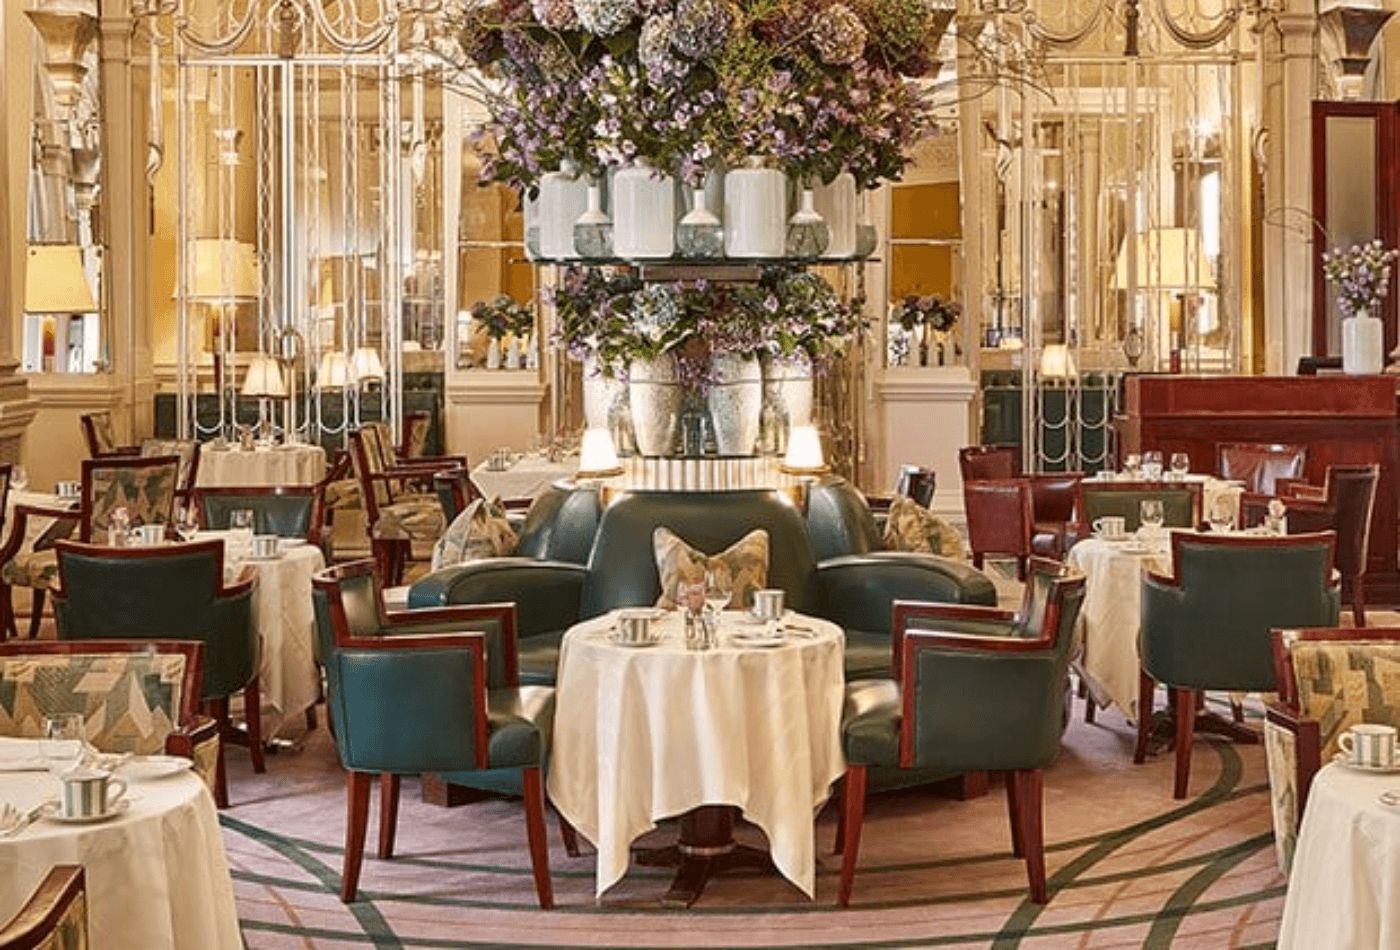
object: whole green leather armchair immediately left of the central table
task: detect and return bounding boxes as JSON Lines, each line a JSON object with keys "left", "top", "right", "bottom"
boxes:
{"left": 314, "top": 561, "right": 557, "bottom": 909}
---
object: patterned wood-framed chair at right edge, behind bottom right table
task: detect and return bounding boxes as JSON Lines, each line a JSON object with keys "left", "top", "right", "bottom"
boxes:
{"left": 1264, "top": 627, "right": 1400, "bottom": 874}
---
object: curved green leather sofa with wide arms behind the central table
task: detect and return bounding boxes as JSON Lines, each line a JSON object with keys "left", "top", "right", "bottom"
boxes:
{"left": 409, "top": 491, "right": 997, "bottom": 683}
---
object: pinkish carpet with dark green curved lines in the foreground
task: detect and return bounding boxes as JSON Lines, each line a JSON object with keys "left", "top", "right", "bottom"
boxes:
{"left": 224, "top": 704, "right": 1284, "bottom": 950}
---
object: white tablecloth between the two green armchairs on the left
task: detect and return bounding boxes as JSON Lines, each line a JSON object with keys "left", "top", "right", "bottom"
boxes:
{"left": 197, "top": 532, "right": 326, "bottom": 739}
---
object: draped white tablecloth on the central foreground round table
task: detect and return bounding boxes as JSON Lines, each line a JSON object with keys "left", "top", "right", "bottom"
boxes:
{"left": 549, "top": 613, "right": 846, "bottom": 897}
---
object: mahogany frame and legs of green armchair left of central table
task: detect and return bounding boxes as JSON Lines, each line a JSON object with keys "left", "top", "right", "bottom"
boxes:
{"left": 312, "top": 560, "right": 554, "bottom": 911}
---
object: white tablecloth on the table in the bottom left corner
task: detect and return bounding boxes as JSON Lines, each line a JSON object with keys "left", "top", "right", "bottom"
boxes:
{"left": 0, "top": 742, "right": 242, "bottom": 950}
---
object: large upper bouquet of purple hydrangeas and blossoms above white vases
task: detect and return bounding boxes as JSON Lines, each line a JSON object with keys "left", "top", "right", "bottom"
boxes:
{"left": 448, "top": 0, "right": 948, "bottom": 190}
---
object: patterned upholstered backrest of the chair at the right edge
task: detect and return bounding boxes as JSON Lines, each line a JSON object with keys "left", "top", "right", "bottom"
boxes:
{"left": 1291, "top": 631, "right": 1400, "bottom": 763}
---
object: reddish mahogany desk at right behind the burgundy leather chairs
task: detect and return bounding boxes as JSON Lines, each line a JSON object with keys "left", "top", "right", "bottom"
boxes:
{"left": 1121, "top": 376, "right": 1400, "bottom": 603}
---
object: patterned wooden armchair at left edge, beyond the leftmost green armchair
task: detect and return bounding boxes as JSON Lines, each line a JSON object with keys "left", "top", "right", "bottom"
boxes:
{"left": 0, "top": 456, "right": 179, "bottom": 639}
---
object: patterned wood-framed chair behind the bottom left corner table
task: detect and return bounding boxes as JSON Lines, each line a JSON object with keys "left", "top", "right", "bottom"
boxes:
{"left": 0, "top": 639, "right": 218, "bottom": 791}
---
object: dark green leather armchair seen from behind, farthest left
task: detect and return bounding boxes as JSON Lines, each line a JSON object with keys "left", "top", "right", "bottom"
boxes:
{"left": 53, "top": 540, "right": 266, "bottom": 807}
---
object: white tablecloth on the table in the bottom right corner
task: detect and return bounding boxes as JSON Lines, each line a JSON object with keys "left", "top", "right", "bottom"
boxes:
{"left": 1278, "top": 764, "right": 1400, "bottom": 950}
